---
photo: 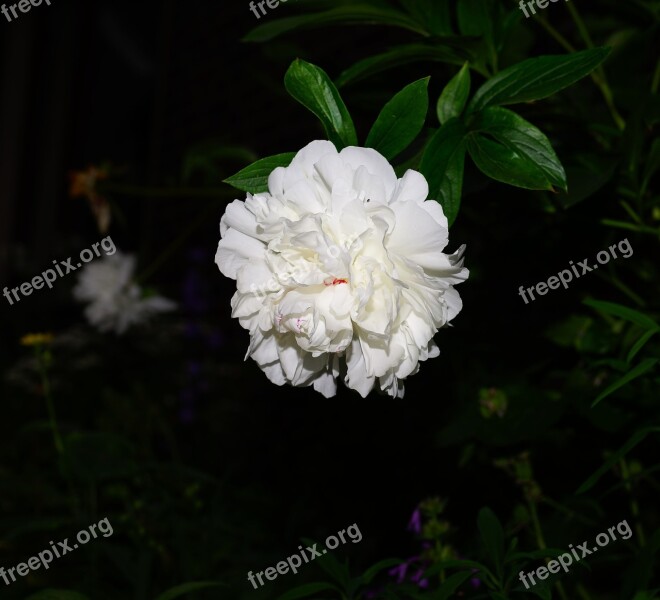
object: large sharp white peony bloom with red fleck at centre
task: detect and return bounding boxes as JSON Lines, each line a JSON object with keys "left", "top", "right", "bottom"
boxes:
{"left": 215, "top": 141, "right": 468, "bottom": 397}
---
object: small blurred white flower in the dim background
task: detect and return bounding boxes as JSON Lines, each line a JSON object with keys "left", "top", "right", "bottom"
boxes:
{"left": 73, "top": 252, "right": 176, "bottom": 334}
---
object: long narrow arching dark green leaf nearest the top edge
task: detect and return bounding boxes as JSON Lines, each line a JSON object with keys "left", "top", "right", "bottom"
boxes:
{"left": 243, "top": 4, "right": 429, "bottom": 42}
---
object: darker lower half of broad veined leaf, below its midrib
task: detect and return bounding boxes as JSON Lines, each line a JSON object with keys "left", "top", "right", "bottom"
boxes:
{"left": 467, "top": 133, "right": 552, "bottom": 191}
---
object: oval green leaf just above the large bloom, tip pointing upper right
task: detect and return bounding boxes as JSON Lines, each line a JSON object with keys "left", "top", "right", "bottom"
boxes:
{"left": 365, "top": 77, "right": 429, "bottom": 160}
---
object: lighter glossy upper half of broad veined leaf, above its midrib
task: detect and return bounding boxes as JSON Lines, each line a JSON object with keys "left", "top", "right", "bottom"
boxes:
{"left": 470, "top": 106, "right": 567, "bottom": 190}
